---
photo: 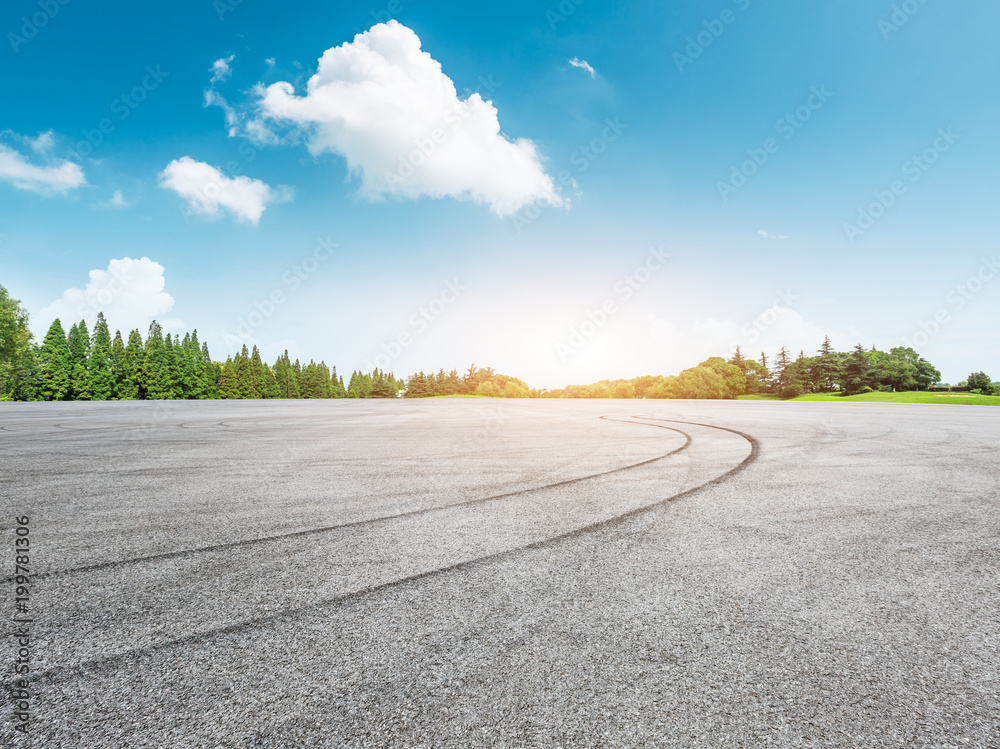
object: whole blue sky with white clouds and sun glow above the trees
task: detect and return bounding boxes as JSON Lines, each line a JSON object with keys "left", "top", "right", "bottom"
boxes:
{"left": 0, "top": 0, "right": 1000, "bottom": 387}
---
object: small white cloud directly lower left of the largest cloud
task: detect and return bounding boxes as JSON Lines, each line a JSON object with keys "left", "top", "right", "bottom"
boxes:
{"left": 160, "top": 156, "right": 292, "bottom": 225}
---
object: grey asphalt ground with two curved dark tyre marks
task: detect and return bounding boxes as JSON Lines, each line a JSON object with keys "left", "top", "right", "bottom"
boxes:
{"left": 0, "top": 400, "right": 1000, "bottom": 749}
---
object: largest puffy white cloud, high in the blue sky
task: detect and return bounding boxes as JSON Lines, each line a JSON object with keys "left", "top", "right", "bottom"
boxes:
{"left": 247, "top": 21, "right": 567, "bottom": 216}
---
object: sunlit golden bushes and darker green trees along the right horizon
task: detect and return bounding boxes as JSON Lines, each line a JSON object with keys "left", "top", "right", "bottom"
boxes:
{"left": 544, "top": 337, "right": 941, "bottom": 398}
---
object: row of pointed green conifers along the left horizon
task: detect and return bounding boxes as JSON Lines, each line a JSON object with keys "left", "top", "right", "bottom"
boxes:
{"left": 0, "top": 310, "right": 403, "bottom": 401}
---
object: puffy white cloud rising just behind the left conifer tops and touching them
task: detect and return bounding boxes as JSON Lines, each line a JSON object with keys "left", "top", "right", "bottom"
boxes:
{"left": 32, "top": 257, "right": 179, "bottom": 335}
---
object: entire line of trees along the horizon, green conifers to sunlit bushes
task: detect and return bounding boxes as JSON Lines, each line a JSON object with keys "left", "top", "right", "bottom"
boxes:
{"left": 0, "top": 286, "right": 998, "bottom": 401}
